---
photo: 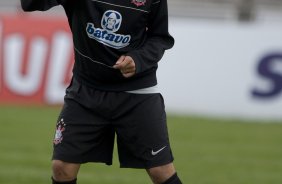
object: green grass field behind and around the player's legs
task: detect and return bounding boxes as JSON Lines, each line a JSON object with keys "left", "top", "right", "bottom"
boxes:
{"left": 0, "top": 106, "right": 282, "bottom": 184}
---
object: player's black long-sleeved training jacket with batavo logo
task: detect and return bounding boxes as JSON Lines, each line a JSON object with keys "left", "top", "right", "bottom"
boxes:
{"left": 21, "top": 0, "right": 174, "bottom": 91}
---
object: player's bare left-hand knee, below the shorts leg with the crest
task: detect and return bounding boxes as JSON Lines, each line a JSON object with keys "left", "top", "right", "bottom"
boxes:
{"left": 52, "top": 160, "right": 79, "bottom": 181}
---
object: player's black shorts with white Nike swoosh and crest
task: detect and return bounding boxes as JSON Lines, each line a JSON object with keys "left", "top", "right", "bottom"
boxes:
{"left": 53, "top": 79, "right": 173, "bottom": 169}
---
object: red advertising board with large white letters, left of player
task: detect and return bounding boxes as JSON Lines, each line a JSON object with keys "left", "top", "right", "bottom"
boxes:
{"left": 0, "top": 14, "right": 73, "bottom": 104}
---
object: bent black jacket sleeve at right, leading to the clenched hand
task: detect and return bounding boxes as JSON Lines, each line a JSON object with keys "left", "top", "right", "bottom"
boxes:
{"left": 127, "top": 0, "right": 174, "bottom": 73}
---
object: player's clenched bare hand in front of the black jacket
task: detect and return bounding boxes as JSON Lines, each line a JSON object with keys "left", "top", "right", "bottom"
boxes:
{"left": 113, "top": 56, "right": 136, "bottom": 78}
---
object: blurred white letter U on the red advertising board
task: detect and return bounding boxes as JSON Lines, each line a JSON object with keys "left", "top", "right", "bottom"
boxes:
{"left": 3, "top": 34, "right": 47, "bottom": 96}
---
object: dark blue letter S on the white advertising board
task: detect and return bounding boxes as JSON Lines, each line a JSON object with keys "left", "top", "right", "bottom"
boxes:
{"left": 252, "top": 52, "right": 282, "bottom": 99}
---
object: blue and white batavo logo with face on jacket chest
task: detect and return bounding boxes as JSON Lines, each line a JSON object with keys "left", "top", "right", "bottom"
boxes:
{"left": 86, "top": 10, "right": 131, "bottom": 49}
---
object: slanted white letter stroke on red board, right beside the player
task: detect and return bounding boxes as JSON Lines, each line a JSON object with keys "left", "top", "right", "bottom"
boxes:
{"left": 45, "top": 32, "right": 72, "bottom": 104}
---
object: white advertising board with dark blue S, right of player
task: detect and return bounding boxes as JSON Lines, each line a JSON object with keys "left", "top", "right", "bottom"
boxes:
{"left": 159, "top": 18, "right": 282, "bottom": 120}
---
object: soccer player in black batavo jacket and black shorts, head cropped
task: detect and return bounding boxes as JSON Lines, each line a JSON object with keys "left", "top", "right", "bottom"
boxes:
{"left": 21, "top": 0, "right": 181, "bottom": 184}
